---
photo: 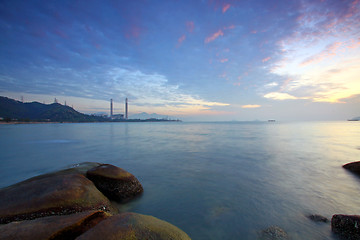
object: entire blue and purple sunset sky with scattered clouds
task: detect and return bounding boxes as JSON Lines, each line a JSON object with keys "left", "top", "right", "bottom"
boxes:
{"left": 0, "top": 0, "right": 360, "bottom": 121}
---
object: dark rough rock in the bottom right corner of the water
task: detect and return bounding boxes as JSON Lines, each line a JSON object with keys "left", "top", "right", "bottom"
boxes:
{"left": 331, "top": 214, "right": 360, "bottom": 240}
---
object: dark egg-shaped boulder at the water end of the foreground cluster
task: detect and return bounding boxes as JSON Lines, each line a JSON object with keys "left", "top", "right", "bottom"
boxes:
{"left": 86, "top": 164, "right": 143, "bottom": 202}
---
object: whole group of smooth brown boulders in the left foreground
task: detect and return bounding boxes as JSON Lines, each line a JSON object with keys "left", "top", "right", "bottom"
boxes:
{"left": 0, "top": 163, "right": 190, "bottom": 240}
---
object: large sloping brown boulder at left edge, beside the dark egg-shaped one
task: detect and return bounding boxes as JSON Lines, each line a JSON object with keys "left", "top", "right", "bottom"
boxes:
{"left": 0, "top": 171, "right": 115, "bottom": 224}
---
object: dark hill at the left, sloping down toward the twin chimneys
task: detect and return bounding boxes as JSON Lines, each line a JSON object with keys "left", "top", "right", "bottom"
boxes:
{"left": 0, "top": 96, "right": 107, "bottom": 122}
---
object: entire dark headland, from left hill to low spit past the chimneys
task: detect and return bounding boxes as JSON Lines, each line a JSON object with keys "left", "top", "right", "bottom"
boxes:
{"left": 0, "top": 96, "right": 180, "bottom": 123}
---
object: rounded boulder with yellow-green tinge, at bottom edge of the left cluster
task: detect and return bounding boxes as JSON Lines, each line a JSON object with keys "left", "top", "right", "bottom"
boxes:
{"left": 76, "top": 213, "right": 190, "bottom": 240}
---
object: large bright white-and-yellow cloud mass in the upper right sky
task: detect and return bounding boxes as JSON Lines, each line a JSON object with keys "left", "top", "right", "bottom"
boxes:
{"left": 264, "top": 1, "right": 360, "bottom": 103}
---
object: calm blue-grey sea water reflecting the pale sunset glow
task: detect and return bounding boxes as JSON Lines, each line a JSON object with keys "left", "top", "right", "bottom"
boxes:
{"left": 0, "top": 122, "right": 360, "bottom": 240}
